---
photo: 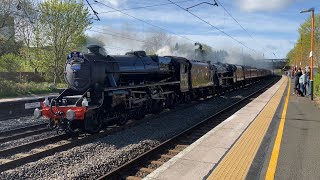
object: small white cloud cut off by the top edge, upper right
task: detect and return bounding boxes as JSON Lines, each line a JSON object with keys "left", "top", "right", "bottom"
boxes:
{"left": 236, "top": 0, "right": 297, "bottom": 12}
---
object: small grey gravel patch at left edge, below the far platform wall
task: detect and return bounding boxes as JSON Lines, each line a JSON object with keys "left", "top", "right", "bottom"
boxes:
{"left": 0, "top": 116, "right": 46, "bottom": 132}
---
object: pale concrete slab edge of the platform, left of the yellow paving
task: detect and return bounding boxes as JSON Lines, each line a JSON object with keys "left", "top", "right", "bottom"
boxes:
{"left": 144, "top": 77, "right": 287, "bottom": 180}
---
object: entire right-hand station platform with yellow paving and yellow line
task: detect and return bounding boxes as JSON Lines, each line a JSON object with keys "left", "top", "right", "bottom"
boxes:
{"left": 144, "top": 76, "right": 320, "bottom": 180}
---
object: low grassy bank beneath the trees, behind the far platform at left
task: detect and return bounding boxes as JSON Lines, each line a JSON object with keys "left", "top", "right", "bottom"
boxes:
{"left": 0, "top": 78, "right": 66, "bottom": 98}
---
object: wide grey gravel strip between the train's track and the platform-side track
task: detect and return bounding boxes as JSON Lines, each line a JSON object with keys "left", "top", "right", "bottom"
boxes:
{"left": 0, "top": 77, "right": 278, "bottom": 179}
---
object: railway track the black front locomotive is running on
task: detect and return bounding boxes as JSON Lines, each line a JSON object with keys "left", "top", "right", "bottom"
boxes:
{"left": 0, "top": 117, "right": 154, "bottom": 172}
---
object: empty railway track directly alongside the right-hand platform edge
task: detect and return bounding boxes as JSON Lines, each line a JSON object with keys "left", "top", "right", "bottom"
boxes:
{"left": 99, "top": 80, "right": 276, "bottom": 180}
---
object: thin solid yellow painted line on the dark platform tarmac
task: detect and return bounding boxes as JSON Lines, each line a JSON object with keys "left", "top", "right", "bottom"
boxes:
{"left": 266, "top": 79, "right": 291, "bottom": 180}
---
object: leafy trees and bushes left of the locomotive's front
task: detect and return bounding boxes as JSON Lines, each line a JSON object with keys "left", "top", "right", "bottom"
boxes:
{"left": 0, "top": 0, "right": 91, "bottom": 98}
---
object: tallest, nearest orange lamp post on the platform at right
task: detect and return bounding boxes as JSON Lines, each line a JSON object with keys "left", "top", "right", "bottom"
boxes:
{"left": 300, "top": 8, "right": 314, "bottom": 101}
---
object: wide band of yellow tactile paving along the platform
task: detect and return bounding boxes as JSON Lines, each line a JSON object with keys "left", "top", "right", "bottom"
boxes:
{"left": 208, "top": 79, "right": 288, "bottom": 180}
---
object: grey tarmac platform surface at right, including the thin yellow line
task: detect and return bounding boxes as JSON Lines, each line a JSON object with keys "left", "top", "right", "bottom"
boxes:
{"left": 260, "top": 80, "right": 320, "bottom": 180}
